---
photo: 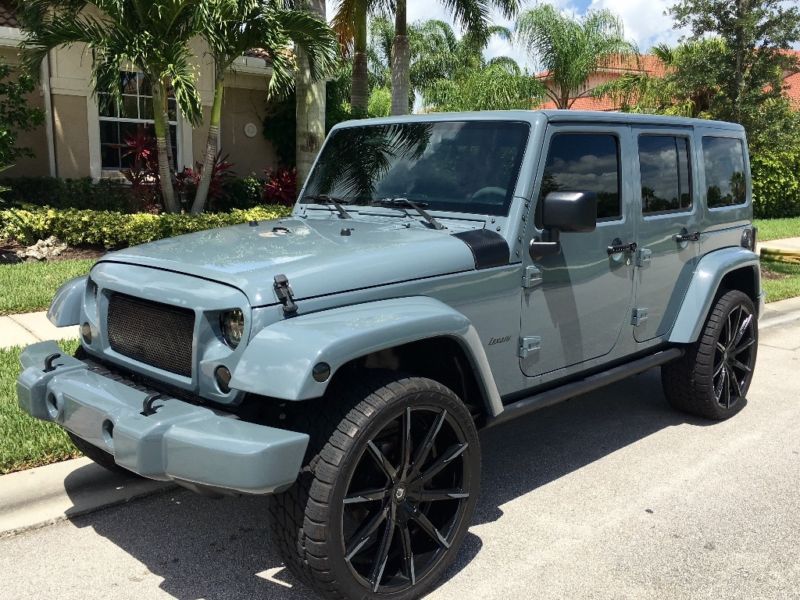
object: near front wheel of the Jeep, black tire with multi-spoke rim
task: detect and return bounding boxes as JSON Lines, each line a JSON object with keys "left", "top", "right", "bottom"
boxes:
{"left": 270, "top": 373, "right": 480, "bottom": 600}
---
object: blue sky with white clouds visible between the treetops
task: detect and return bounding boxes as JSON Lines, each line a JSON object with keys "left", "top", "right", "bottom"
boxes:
{"left": 327, "top": 0, "right": 685, "bottom": 70}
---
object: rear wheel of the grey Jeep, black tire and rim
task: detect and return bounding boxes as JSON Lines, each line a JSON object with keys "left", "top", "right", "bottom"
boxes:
{"left": 661, "top": 290, "right": 758, "bottom": 421}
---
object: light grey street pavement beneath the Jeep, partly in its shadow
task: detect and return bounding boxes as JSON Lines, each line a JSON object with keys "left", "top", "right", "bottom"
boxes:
{"left": 0, "top": 322, "right": 800, "bottom": 600}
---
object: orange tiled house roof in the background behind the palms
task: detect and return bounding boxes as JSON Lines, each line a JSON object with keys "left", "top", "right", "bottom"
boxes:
{"left": 536, "top": 50, "right": 800, "bottom": 111}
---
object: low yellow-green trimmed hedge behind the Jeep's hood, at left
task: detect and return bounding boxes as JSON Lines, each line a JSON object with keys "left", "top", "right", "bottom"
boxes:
{"left": 0, "top": 205, "right": 291, "bottom": 248}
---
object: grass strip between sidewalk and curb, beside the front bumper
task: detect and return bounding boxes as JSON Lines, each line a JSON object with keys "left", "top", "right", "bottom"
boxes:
{"left": 0, "top": 341, "right": 80, "bottom": 475}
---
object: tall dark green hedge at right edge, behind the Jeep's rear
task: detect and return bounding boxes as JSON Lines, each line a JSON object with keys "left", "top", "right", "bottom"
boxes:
{"left": 750, "top": 145, "right": 800, "bottom": 219}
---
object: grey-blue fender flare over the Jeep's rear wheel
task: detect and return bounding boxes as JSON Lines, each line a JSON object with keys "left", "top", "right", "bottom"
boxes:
{"left": 669, "top": 248, "right": 761, "bottom": 344}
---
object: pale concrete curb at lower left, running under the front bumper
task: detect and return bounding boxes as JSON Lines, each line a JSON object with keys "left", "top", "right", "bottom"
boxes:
{"left": 0, "top": 458, "right": 175, "bottom": 539}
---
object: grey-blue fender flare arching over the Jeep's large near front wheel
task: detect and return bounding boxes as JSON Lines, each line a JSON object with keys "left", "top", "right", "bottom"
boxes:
{"left": 230, "top": 296, "right": 502, "bottom": 415}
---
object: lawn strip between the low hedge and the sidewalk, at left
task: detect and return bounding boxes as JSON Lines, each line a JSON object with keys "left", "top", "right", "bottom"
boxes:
{"left": 0, "top": 259, "right": 95, "bottom": 315}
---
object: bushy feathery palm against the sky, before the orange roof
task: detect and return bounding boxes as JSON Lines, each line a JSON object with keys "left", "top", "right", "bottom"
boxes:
{"left": 515, "top": 4, "right": 636, "bottom": 109}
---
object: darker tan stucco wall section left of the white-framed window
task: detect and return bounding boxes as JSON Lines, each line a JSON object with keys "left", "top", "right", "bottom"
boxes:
{"left": 53, "top": 94, "right": 89, "bottom": 178}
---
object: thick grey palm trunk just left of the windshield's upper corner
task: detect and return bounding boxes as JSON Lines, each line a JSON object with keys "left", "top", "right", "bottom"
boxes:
{"left": 295, "top": 0, "right": 326, "bottom": 185}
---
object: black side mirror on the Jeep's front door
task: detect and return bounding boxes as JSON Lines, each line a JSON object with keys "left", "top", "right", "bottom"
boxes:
{"left": 528, "top": 192, "right": 597, "bottom": 260}
